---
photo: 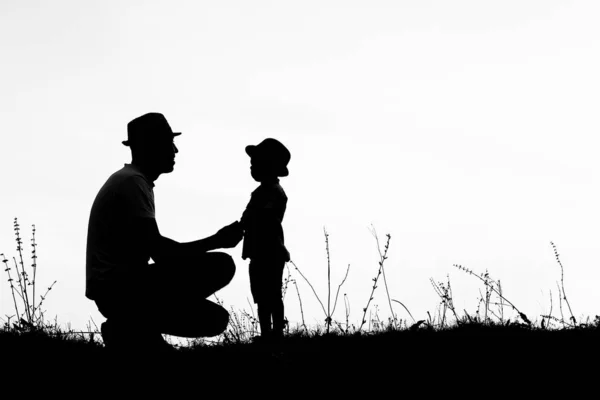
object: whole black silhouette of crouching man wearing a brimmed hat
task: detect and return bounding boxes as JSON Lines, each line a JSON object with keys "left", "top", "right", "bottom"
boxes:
{"left": 86, "top": 113, "right": 243, "bottom": 352}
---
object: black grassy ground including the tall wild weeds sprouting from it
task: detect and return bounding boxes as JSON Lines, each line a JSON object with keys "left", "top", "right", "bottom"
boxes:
{"left": 0, "top": 225, "right": 600, "bottom": 398}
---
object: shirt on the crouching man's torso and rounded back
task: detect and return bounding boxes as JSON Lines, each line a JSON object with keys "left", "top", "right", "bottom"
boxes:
{"left": 85, "top": 164, "right": 155, "bottom": 299}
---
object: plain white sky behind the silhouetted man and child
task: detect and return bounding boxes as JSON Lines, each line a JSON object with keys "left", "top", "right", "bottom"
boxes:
{"left": 0, "top": 0, "right": 600, "bottom": 329}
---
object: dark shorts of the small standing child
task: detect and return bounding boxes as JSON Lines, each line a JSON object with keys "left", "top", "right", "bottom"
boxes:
{"left": 249, "top": 259, "right": 285, "bottom": 303}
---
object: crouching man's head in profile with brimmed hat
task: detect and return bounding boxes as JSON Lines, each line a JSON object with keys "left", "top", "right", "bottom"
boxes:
{"left": 123, "top": 113, "right": 181, "bottom": 177}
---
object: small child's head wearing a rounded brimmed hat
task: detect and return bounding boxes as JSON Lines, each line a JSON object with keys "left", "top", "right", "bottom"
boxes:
{"left": 246, "top": 138, "right": 291, "bottom": 182}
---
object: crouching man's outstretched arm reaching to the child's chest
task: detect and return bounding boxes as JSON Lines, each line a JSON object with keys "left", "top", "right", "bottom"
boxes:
{"left": 134, "top": 218, "right": 242, "bottom": 262}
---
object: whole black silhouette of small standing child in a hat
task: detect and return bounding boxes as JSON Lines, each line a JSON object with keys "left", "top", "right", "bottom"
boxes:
{"left": 241, "top": 138, "right": 290, "bottom": 340}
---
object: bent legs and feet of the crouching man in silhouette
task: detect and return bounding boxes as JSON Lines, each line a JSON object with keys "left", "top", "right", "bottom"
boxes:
{"left": 92, "top": 252, "right": 235, "bottom": 351}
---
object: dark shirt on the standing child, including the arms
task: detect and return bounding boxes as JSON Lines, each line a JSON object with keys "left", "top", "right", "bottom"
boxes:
{"left": 241, "top": 179, "right": 290, "bottom": 262}
